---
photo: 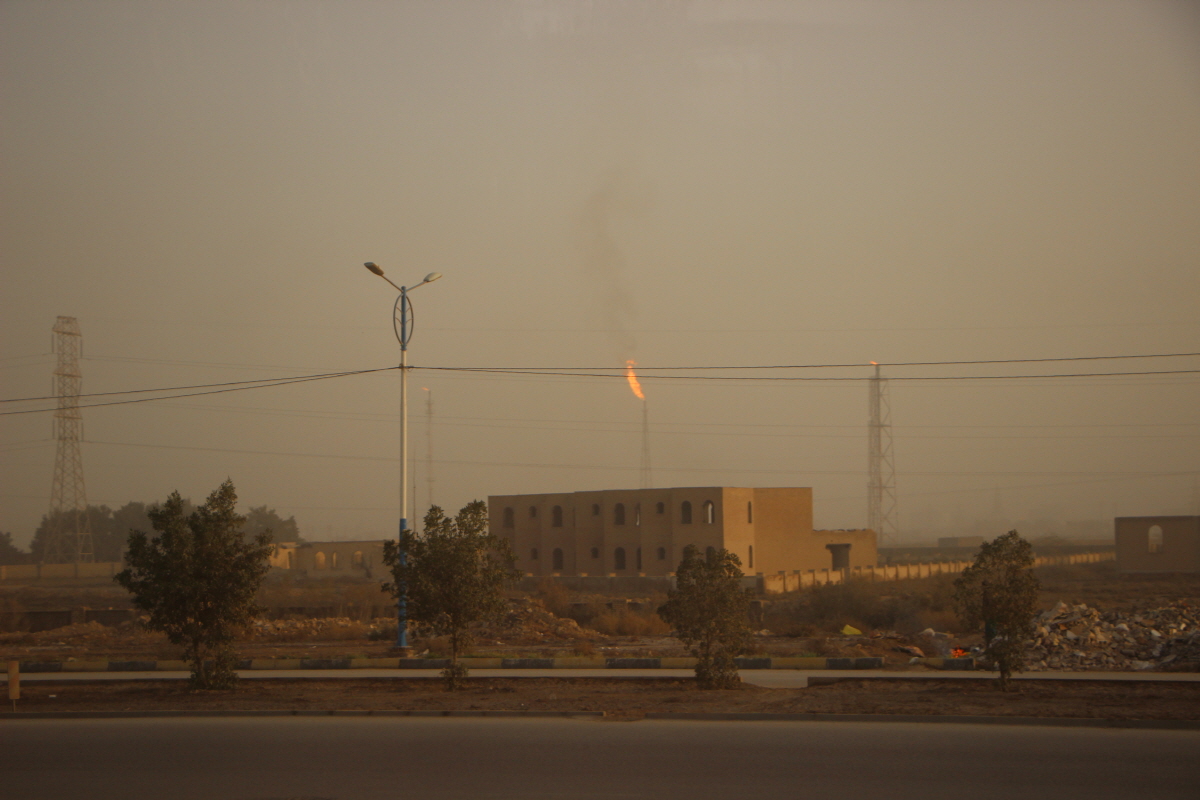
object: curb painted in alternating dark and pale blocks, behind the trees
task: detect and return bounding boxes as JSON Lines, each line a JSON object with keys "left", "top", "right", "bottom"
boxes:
{"left": 9, "top": 657, "right": 892, "bottom": 674}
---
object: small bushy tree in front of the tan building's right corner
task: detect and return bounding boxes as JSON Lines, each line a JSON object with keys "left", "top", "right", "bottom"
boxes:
{"left": 659, "top": 545, "right": 750, "bottom": 688}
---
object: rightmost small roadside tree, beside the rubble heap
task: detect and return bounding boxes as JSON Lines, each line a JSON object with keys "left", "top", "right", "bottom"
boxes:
{"left": 954, "top": 530, "right": 1039, "bottom": 691}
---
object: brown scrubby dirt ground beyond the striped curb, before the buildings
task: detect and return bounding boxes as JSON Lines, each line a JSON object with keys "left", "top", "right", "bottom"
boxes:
{"left": 0, "top": 563, "right": 1200, "bottom": 669}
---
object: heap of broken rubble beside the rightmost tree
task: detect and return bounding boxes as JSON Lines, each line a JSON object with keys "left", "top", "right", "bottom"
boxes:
{"left": 1025, "top": 602, "right": 1200, "bottom": 670}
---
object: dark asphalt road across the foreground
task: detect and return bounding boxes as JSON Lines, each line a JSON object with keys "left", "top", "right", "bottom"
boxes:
{"left": 0, "top": 717, "right": 1200, "bottom": 800}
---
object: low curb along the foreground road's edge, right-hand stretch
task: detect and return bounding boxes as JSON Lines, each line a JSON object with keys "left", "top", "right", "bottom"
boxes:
{"left": 646, "top": 711, "right": 1200, "bottom": 730}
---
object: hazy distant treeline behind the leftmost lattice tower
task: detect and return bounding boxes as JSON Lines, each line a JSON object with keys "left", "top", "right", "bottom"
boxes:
{"left": 0, "top": 500, "right": 304, "bottom": 565}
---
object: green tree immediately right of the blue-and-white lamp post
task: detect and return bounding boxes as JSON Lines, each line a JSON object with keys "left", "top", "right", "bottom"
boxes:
{"left": 383, "top": 500, "right": 520, "bottom": 691}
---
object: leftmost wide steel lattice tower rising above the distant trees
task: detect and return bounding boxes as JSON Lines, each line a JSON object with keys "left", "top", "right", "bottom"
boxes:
{"left": 42, "top": 317, "right": 96, "bottom": 564}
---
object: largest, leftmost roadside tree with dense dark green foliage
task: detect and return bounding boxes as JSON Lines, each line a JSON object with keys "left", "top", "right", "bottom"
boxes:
{"left": 114, "top": 480, "right": 274, "bottom": 688}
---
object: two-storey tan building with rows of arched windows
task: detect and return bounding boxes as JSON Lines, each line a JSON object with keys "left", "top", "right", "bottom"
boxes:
{"left": 487, "top": 487, "right": 877, "bottom": 577}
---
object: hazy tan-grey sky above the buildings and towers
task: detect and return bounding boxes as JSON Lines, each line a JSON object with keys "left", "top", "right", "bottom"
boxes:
{"left": 0, "top": 0, "right": 1200, "bottom": 543}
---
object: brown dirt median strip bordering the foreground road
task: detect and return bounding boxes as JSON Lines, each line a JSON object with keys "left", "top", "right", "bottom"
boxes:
{"left": 9, "top": 678, "right": 1200, "bottom": 720}
